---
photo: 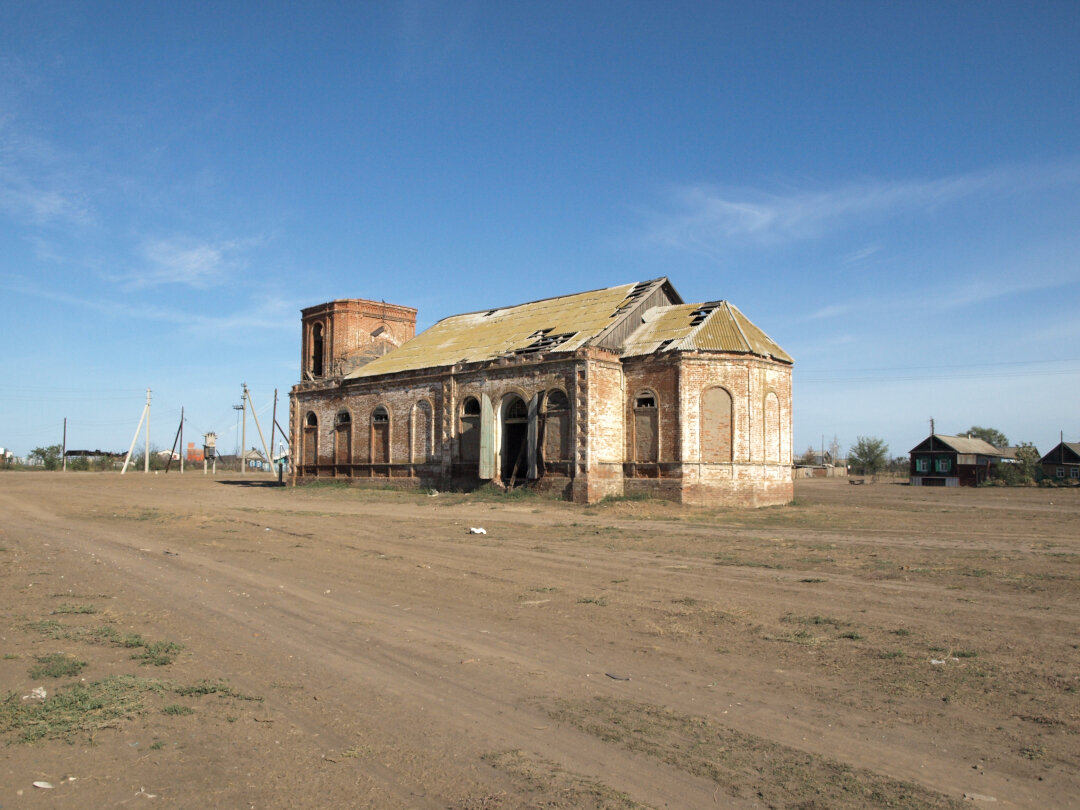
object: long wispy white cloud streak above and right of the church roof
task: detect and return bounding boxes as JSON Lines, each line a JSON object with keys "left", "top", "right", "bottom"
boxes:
{"left": 647, "top": 161, "right": 1080, "bottom": 260}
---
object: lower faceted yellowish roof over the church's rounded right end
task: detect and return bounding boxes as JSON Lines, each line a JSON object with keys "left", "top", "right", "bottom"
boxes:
{"left": 622, "top": 301, "right": 794, "bottom": 363}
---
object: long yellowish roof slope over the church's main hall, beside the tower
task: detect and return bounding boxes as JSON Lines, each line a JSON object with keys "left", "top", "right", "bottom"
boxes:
{"left": 346, "top": 279, "right": 667, "bottom": 379}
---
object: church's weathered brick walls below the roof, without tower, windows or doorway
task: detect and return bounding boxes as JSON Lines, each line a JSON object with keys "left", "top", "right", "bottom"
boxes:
{"left": 292, "top": 349, "right": 793, "bottom": 507}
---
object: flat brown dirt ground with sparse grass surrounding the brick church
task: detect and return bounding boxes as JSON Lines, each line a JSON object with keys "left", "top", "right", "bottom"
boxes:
{"left": 0, "top": 471, "right": 1080, "bottom": 810}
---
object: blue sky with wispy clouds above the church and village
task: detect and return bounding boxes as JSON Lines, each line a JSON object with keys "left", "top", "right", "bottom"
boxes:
{"left": 0, "top": 0, "right": 1080, "bottom": 462}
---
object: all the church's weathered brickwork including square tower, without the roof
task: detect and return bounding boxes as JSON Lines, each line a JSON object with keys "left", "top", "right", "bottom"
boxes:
{"left": 291, "top": 285, "right": 792, "bottom": 507}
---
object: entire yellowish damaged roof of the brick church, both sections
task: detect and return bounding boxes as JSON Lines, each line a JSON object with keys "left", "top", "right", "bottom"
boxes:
{"left": 346, "top": 278, "right": 793, "bottom": 379}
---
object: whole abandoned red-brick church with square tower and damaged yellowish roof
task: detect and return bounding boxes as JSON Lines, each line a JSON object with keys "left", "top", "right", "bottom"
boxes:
{"left": 291, "top": 279, "right": 793, "bottom": 507}
